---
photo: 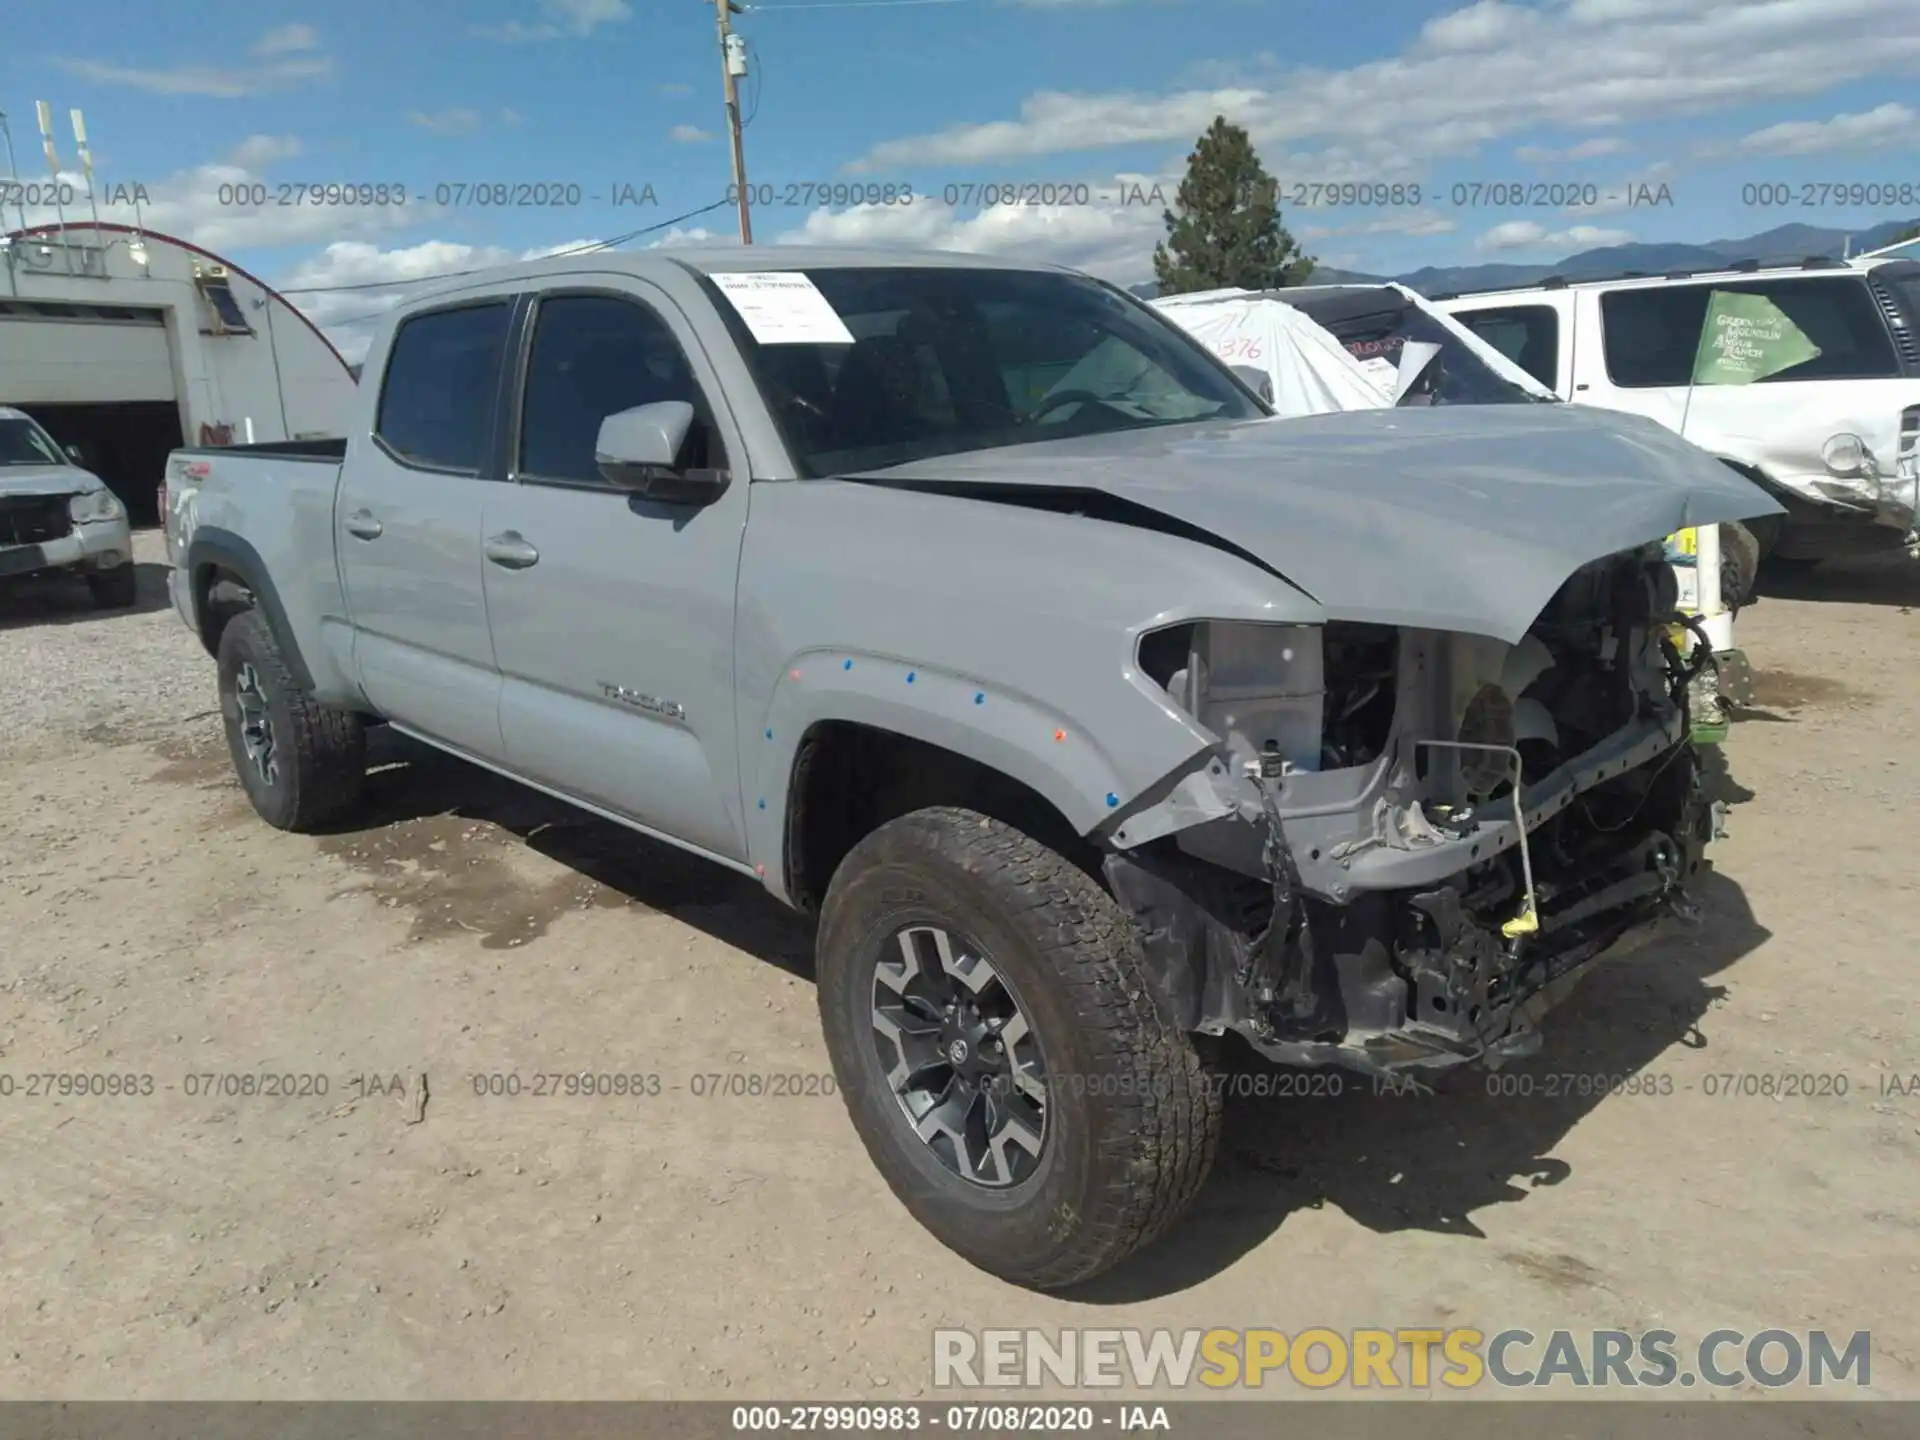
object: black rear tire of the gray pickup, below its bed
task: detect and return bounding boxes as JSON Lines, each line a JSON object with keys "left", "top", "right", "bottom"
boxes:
{"left": 219, "top": 611, "right": 367, "bottom": 831}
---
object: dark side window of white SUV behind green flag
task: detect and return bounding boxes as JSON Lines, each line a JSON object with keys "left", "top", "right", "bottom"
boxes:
{"left": 1599, "top": 275, "right": 1899, "bottom": 390}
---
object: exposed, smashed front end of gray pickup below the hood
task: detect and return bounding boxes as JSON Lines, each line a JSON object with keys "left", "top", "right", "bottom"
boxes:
{"left": 1104, "top": 545, "right": 1715, "bottom": 1073}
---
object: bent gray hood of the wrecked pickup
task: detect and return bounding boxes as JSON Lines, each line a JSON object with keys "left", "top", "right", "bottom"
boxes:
{"left": 849, "top": 405, "right": 1780, "bottom": 643}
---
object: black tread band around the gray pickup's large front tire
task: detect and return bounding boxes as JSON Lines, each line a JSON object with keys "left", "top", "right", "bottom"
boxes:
{"left": 828, "top": 806, "right": 1221, "bottom": 1290}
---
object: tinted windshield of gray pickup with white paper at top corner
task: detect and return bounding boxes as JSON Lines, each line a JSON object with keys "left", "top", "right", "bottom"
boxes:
{"left": 716, "top": 267, "right": 1267, "bottom": 476}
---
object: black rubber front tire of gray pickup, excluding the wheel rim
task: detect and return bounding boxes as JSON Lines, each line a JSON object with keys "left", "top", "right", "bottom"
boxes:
{"left": 816, "top": 806, "right": 1221, "bottom": 1290}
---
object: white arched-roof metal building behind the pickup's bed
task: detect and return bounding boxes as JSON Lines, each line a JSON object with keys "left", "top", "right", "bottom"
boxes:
{"left": 0, "top": 223, "right": 355, "bottom": 524}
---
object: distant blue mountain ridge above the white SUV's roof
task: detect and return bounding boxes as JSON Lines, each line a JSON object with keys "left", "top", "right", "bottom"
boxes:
{"left": 1127, "top": 217, "right": 1920, "bottom": 300}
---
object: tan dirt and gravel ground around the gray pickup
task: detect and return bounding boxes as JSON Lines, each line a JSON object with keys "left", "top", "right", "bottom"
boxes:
{"left": 0, "top": 538, "right": 1920, "bottom": 1398}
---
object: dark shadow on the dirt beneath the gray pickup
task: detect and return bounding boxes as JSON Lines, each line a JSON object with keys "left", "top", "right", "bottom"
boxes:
{"left": 288, "top": 730, "right": 1768, "bottom": 1304}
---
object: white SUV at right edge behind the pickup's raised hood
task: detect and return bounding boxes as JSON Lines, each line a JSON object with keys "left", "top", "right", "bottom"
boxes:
{"left": 1434, "top": 255, "right": 1920, "bottom": 564}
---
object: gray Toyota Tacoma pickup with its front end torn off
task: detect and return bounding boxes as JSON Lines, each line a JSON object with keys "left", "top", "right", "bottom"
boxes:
{"left": 167, "top": 248, "right": 1774, "bottom": 1286}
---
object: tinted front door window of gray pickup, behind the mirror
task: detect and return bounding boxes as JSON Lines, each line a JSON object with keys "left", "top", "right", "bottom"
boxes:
{"left": 516, "top": 296, "right": 726, "bottom": 484}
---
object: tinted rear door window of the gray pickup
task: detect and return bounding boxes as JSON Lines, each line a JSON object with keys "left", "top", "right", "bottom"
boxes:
{"left": 374, "top": 301, "right": 511, "bottom": 474}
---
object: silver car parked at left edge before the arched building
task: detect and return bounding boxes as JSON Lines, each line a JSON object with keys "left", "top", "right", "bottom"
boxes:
{"left": 0, "top": 405, "right": 134, "bottom": 609}
